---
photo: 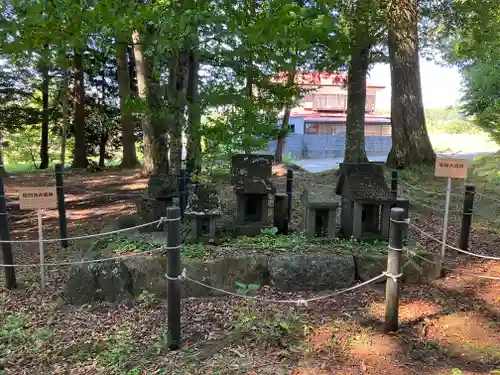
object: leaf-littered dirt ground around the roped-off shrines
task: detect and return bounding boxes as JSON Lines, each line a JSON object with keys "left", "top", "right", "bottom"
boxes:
{"left": 0, "top": 168, "right": 500, "bottom": 375}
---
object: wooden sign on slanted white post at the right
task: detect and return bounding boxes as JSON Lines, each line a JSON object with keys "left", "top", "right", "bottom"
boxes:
{"left": 434, "top": 158, "right": 469, "bottom": 263}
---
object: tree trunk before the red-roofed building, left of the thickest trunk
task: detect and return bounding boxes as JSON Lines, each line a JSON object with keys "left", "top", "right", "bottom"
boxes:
{"left": 344, "top": 46, "right": 370, "bottom": 163}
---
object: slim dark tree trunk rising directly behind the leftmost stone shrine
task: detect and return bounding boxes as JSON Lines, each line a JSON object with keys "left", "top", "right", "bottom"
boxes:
{"left": 186, "top": 45, "right": 201, "bottom": 174}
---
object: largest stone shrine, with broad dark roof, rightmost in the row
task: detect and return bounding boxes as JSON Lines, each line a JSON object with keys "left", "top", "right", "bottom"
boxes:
{"left": 336, "top": 163, "right": 396, "bottom": 240}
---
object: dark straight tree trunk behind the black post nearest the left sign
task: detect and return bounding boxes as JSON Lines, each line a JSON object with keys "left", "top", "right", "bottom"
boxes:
{"left": 72, "top": 51, "right": 88, "bottom": 168}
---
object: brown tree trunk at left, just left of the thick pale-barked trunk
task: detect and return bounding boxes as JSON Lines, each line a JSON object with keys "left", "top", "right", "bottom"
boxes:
{"left": 116, "top": 39, "right": 139, "bottom": 168}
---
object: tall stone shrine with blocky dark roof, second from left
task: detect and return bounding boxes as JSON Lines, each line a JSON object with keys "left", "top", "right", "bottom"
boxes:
{"left": 231, "top": 154, "right": 276, "bottom": 235}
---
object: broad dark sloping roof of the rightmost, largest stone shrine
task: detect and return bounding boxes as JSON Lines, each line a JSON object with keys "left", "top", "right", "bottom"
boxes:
{"left": 335, "top": 163, "right": 396, "bottom": 203}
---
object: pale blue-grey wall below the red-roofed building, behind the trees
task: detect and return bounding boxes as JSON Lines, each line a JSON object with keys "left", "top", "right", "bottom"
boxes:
{"left": 268, "top": 134, "right": 392, "bottom": 159}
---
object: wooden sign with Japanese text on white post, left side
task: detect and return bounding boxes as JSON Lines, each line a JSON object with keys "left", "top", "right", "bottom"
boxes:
{"left": 19, "top": 187, "right": 57, "bottom": 289}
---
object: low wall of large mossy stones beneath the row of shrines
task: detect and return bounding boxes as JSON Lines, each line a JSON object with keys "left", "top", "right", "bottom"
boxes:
{"left": 65, "top": 251, "right": 441, "bottom": 304}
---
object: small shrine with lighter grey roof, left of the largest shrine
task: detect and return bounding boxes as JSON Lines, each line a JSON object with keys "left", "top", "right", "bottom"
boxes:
{"left": 302, "top": 187, "right": 338, "bottom": 237}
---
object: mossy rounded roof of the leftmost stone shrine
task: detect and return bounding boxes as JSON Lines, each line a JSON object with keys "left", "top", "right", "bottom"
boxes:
{"left": 184, "top": 184, "right": 222, "bottom": 217}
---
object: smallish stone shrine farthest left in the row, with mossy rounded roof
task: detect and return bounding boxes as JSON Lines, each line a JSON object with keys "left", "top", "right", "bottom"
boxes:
{"left": 184, "top": 184, "right": 222, "bottom": 242}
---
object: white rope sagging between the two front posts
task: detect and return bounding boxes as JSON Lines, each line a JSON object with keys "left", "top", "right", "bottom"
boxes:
{"left": 165, "top": 268, "right": 386, "bottom": 306}
